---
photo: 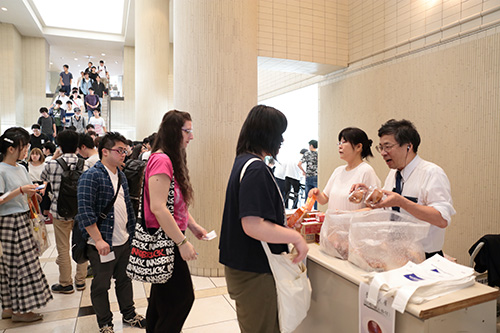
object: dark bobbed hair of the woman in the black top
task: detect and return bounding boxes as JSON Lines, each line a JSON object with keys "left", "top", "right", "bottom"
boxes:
{"left": 236, "top": 105, "right": 288, "bottom": 159}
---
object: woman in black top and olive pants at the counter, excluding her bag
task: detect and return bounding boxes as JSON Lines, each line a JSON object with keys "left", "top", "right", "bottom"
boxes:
{"left": 219, "top": 105, "right": 308, "bottom": 333}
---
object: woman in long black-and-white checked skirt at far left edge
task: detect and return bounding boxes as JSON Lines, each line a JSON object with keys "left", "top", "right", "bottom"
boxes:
{"left": 0, "top": 127, "right": 52, "bottom": 322}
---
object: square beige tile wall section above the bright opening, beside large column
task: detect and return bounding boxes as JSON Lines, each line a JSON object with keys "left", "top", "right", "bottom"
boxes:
{"left": 258, "top": 0, "right": 348, "bottom": 67}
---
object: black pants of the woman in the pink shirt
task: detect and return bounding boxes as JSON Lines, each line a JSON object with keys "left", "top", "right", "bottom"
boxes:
{"left": 146, "top": 246, "right": 194, "bottom": 333}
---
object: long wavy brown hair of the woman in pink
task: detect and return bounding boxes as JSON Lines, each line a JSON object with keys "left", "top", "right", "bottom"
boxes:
{"left": 150, "top": 110, "right": 194, "bottom": 206}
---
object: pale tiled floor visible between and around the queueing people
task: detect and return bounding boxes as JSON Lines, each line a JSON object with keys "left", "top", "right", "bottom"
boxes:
{"left": 0, "top": 225, "right": 239, "bottom": 333}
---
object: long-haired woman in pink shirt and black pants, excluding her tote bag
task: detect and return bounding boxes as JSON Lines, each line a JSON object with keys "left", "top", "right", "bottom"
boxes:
{"left": 144, "top": 110, "right": 207, "bottom": 333}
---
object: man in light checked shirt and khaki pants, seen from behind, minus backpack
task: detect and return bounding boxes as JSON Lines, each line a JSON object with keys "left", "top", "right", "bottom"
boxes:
{"left": 41, "top": 130, "right": 89, "bottom": 294}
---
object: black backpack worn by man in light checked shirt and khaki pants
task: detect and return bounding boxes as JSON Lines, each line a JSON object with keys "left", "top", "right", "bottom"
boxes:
{"left": 56, "top": 157, "right": 85, "bottom": 219}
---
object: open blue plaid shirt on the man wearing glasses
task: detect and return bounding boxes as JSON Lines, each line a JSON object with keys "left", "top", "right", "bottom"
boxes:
{"left": 75, "top": 161, "right": 135, "bottom": 249}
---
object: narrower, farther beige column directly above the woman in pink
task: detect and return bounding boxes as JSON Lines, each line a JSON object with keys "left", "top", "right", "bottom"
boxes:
{"left": 135, "top": 0, "right": 170, "bottom": 140}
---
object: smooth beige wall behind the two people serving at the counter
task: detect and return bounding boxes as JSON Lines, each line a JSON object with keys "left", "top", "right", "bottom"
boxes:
{"left": 319, "top": 28, "right": 500, "bottom": 264}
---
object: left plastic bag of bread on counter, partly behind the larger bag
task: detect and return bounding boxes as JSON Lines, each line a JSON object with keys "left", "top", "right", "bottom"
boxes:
{"left": 319, "top": 210, "right": 353, "bottom": 260}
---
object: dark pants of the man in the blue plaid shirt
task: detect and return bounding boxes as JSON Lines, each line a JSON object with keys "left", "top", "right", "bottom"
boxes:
{"left": 87, "top": 242, "right": 135, "bottom": 327}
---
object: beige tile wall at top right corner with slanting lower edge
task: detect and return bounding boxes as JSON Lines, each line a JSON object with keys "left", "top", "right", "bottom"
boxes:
{"left": 349, "top": 0, "right": 500, "bottom": 64}
